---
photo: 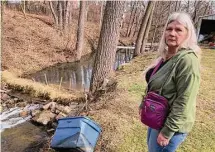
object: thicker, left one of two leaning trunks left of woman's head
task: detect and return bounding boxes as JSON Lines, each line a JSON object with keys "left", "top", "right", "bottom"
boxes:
{"left": 134, "top": 1, "right": 155, "bottom": 56}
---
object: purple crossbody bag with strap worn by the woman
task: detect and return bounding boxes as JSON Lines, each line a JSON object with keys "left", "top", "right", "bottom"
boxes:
{"left": 141, "top": 60, "right": 169, "bottom": 130}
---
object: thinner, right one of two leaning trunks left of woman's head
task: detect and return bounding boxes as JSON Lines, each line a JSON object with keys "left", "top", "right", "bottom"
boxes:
{"left": 141, "top": 2, "right": 156, "bottom": 54}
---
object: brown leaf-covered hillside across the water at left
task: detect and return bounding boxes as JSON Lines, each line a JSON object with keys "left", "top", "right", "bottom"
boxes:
{"left": 2, "top": 10, "right": 99, "bottom": 74}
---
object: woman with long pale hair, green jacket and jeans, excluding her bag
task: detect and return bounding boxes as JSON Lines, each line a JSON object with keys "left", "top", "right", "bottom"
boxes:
{"left": 140, "top": 13, "right": 201, "bottom": 152}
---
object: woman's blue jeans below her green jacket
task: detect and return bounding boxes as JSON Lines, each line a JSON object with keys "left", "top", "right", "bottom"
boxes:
{"left": 147, "top": 128, "right": 187, "bottom": 152}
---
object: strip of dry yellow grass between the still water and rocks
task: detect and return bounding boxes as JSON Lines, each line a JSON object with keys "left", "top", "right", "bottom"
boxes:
{"left": 2, "top": 71, "right": 83, "bottom": 104}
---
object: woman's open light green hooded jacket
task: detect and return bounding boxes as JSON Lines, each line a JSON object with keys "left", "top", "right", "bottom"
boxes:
{"left": 143, "top": 49, "right": 200, "bottom": 139}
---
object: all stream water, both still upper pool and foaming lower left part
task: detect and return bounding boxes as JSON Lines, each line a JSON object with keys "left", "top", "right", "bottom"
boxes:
{"left": 0, "top": 49, "right": 133, "bottom": 152}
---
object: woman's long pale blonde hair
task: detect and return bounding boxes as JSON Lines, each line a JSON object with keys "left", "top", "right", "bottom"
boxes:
{"left": 144, "top": 12, "right": 201, "bottom": 74}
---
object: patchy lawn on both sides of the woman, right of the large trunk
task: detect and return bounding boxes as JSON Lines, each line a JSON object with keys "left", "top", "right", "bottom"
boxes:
{"left": 92, "top": 50, "right": 215, "bottom": 152}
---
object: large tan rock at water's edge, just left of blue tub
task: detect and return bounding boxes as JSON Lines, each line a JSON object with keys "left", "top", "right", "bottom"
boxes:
{"left": 33, "top": 110, "right": 56, "bottom": 125}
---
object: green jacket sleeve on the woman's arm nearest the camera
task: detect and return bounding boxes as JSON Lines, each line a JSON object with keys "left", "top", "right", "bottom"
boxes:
{"left": 161, "top": 57, "right": 200, "bottom": 139}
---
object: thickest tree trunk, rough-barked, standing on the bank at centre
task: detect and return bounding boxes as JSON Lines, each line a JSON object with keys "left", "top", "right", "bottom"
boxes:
{"left": 90, "top": 1, "right": 125, "bottom": 93}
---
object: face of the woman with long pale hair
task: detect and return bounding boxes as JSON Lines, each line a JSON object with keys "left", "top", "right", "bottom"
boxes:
{"left": 165, "top": 21, "right": 188, "bottom": 47}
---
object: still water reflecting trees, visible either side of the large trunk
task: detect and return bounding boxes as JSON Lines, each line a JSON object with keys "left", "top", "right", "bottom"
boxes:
{"left": 30, "top": 49, "right": 133, "bottom": 91}
